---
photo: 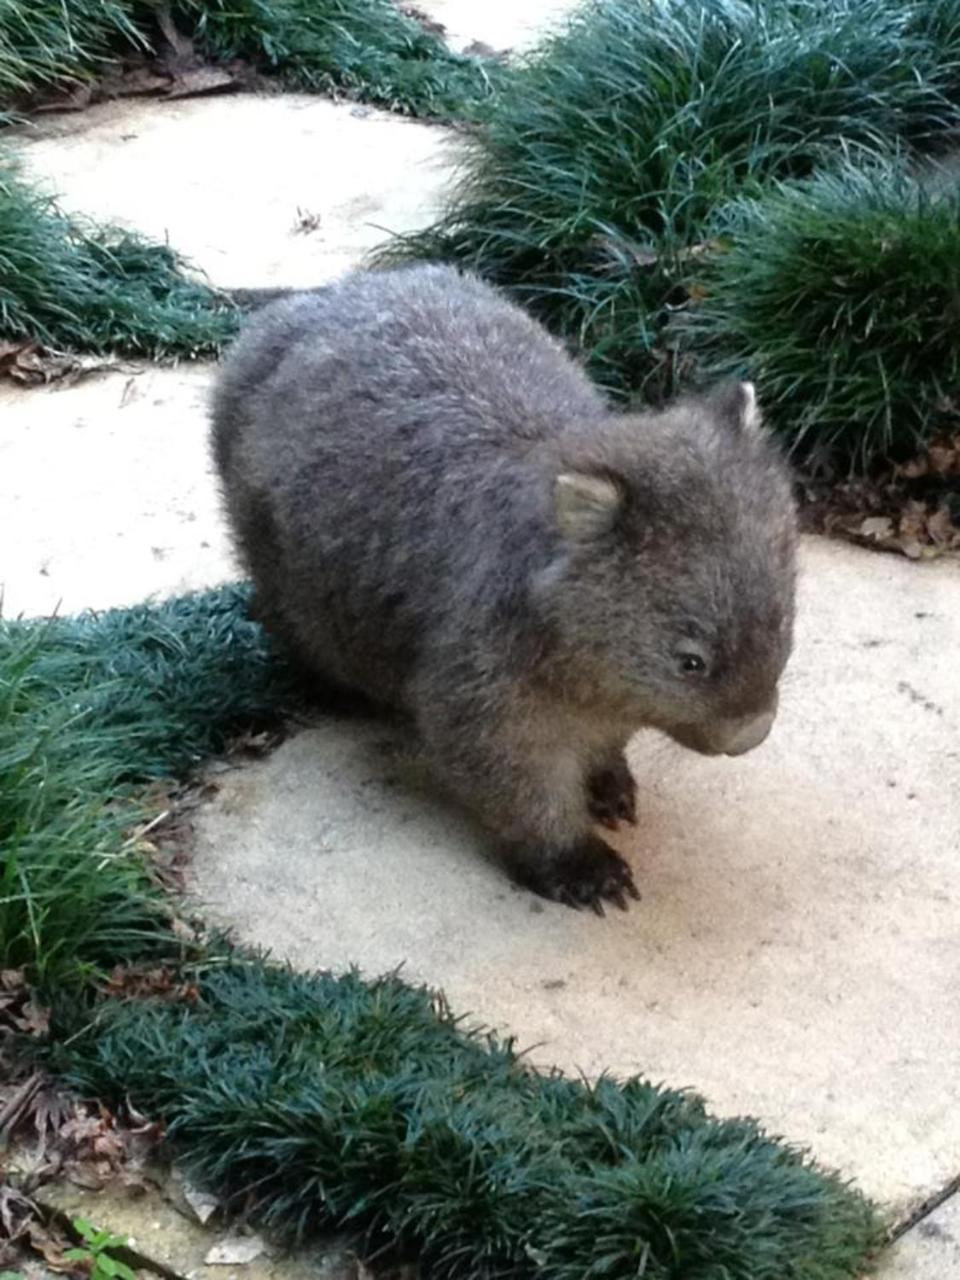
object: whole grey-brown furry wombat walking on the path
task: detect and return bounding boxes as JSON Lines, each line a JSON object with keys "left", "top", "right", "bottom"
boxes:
{"left": 212, "top": 266, "right": 796, "bottom": 911}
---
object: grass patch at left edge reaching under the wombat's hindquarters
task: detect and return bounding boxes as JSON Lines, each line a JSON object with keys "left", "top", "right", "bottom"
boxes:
{"left": 0, "top": 589, "right": 292, "bottom": 992}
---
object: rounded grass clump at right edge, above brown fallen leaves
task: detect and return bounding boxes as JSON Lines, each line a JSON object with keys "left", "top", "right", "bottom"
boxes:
{"left": 677, "top": 164, "right": 960, "bottom": 466}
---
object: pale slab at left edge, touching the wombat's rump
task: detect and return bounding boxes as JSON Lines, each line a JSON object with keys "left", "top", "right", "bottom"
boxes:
{"left": 0, "top": 366, "right": 237, "bottom": 617}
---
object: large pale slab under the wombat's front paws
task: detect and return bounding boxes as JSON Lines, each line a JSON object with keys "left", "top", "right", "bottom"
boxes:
{"left": 188, "top": 540, "right": 960, "bottom": 1207}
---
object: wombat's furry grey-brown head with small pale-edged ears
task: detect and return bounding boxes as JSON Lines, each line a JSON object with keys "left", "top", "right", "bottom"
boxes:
{"left": 538, "top": 383, "right": 796, "bottom": 755}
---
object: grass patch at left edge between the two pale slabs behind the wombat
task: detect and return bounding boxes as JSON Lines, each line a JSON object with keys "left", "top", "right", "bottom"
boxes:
{"left": 0, "top": 159, "right": 238, "bottom": 357}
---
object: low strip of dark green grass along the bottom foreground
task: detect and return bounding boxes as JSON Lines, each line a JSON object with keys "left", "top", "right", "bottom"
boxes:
{"left": 56, "top": 957, "right": 881, "bottom": 1280}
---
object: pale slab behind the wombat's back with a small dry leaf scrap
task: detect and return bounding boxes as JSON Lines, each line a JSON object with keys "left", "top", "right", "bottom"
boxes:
{"left": 6, "top": 93, "right": 458, "bottom": 288}
